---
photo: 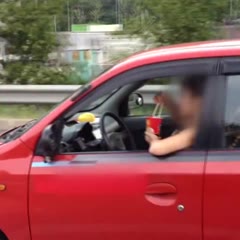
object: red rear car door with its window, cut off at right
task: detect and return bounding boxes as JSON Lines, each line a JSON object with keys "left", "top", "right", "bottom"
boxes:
{"left": 204, "top": 58, "right": 240, "bottom": 240}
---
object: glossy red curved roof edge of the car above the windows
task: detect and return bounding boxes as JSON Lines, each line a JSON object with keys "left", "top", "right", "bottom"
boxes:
{"left": 93, "top": 40, "right": 240, "bottom": 85}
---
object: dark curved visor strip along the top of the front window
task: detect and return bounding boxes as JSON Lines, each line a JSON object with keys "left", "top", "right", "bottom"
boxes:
{"left": 63, "top": 58, "right": 219, "bottom": 119}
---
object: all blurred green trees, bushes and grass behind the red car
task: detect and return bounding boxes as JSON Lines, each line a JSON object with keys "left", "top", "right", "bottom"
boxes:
{"left": 0, "top": 0, "right": 237, "bottom": 118}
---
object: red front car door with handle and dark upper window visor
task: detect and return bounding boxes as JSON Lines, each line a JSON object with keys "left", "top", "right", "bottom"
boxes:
{"left": 29, "top": 59, "right": 217, "bottom": 240}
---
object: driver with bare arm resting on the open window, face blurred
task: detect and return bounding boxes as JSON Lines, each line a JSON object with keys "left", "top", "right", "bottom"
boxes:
{"left": 145, "top": 75, "right": 207, "bottom": 156}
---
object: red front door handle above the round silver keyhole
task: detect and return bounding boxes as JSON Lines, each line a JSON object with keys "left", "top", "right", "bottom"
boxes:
{"left": 145, "top": 183, "right": 177, "bottom": 206}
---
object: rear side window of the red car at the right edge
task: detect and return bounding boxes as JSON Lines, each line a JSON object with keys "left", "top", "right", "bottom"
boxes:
{"left": 224, "top": 75, "right": 240, "bottom": 148}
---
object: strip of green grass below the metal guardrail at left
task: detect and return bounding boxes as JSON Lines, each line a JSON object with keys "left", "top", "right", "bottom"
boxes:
{"left": 0, "top": 104, "right": 52, "bottom": 119}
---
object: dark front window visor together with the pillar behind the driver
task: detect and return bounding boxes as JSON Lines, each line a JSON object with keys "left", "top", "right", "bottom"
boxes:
{"left": 70, "top": 58, "right": 224, "bottom": 150}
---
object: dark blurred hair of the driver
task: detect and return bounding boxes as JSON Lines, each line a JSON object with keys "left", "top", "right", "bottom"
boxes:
{"left": 182, "top": 75, "right": 207, "bottom": 97}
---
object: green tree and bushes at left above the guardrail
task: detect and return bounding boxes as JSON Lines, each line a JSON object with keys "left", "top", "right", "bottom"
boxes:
{"left": 0, "top": 0, "right": 79, "bottom": 84}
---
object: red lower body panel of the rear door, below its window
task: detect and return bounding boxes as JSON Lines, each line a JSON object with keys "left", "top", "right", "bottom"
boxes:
{"left": 204, "top": 151, "right": 240, "bottom": 240}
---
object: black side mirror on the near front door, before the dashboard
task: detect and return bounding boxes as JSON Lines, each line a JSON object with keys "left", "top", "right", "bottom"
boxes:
{"left": 35, "top": 120, "right": 64, "bottom": 162}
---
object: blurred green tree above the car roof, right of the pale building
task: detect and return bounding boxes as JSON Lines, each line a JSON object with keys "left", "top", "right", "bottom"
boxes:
{"left": 123, "top": 0, "right": 228, "bottom": 45}
